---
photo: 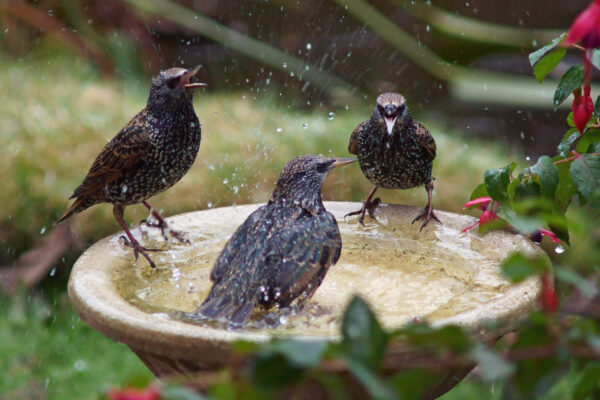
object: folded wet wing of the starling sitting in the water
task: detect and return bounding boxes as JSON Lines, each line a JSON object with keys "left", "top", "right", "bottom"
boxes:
{"left": 256, "top": 212, "right": 342, "bottom": 306}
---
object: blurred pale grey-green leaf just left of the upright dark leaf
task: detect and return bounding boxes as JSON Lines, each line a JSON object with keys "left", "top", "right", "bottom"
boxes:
{"left": 262, "top": 339, "right": 327, "bottom": 368}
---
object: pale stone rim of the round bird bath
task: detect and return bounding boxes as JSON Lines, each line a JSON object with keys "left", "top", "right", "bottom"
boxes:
{"left": 68, "top": 202, "right": 542, "bottom": 364}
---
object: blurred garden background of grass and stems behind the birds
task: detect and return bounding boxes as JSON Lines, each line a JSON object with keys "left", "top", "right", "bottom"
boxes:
{"left": 0, "top": 0, "right": 588, "bottom": 399}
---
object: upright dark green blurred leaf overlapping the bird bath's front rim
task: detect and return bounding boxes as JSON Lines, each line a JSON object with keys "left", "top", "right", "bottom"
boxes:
{"left": 342, "top": 296, "right": 387, "bottom": 370}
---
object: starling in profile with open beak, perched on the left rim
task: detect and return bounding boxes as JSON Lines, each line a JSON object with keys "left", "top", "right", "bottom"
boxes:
{"left": 58, "top": 67, "right": 206, "bottom": 268}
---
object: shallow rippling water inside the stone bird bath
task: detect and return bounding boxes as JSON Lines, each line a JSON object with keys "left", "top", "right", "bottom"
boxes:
{"left": 113, "top": 203, "right": 535, "bottom": 336}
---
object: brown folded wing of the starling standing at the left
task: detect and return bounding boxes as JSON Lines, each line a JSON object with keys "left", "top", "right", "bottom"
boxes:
{"left": 71, "top": 124, "right": 153, "bottom": 198}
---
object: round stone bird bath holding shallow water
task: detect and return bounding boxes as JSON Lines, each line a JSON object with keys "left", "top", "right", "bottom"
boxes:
{"left": 69, "top": 202, "right": 541, "bottom": 390}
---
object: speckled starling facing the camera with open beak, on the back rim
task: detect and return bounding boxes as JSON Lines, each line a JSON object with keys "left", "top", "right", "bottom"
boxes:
{"left": 347, "top": 93, "right": 441, "bottom": 229}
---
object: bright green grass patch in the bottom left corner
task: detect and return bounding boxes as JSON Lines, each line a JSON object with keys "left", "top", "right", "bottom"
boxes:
{"left": 0, "top": 292, "right": 153, "bottom": 400}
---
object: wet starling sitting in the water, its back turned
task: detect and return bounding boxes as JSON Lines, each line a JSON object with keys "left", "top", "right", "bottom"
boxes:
{"left": 195, "top": 155, "right": 356, "bottom": 326}
